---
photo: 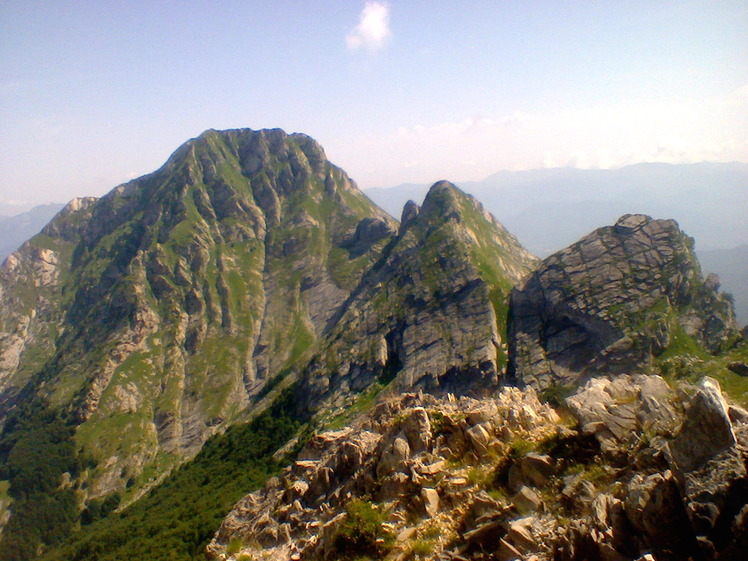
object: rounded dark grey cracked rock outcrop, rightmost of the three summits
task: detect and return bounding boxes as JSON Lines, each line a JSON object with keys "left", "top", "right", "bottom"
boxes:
{"left": 508, "top": 215, "right": 737, "bottom": 389}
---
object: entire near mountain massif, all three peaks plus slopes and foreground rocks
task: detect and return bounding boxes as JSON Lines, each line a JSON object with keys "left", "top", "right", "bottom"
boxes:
{"left": 0, "top": 129, "right": 748, "bottom": 561}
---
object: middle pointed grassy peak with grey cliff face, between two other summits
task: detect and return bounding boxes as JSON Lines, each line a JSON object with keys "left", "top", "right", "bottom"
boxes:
{"left": 297, "top": 181, "right": 535, "bottom": 411}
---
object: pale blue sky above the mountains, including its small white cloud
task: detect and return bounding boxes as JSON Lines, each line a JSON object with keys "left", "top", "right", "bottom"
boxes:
{"left": 0, "top": 0, "right": 748, "bottom": 208}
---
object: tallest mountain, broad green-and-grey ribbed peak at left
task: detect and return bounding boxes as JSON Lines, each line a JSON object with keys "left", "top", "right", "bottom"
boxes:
{"left": 0, "top": 129, "right": 396, "bottom": 508}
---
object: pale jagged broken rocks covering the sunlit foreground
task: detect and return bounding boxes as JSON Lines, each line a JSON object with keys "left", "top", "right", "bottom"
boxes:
{"left": 208, "top": 375, "right": 748, "bottom": 561}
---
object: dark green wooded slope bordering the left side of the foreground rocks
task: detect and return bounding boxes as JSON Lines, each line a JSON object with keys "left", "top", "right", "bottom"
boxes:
{"left": 41, "top": 402, "right": 299, "bottom": 561}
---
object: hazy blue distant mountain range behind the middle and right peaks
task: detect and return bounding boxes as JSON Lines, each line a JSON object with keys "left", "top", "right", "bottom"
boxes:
{"left": 366, "top": 162, "right": 748, "bottom": 323}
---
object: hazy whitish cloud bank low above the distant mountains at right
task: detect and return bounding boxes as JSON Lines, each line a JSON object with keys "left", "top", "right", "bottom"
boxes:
{"left": 327, "top": 84, "right": 748, "bottom": 187}
